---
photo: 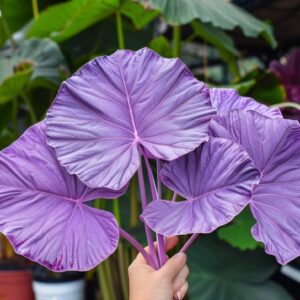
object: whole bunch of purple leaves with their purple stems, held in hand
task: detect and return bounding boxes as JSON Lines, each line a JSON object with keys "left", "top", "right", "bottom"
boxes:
{"left": 0, "top": 48, "right": 300, "bottom": 272}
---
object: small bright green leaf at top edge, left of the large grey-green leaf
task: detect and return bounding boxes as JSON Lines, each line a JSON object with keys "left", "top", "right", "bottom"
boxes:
{"left": 120, "top": 0, "right": 159, "bottom": 29}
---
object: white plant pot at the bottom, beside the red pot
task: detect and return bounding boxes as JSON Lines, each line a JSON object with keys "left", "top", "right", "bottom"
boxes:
{"left": 33, "top": 278, "right": 85, "bottom": 300}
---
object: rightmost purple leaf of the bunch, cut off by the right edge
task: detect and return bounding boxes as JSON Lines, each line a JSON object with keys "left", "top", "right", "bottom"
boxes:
{"left": 210, "top": 111, "right": 300, "bottom": 264}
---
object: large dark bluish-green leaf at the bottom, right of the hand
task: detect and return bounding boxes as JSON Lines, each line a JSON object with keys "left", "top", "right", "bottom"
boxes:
{"left": 188, "top": 235, "right": 292, "bottom": 300}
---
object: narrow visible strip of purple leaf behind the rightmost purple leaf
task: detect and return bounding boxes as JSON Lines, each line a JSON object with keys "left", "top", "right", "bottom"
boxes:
{"left": 209, "top": 88, "right": 282, "bottom": 118}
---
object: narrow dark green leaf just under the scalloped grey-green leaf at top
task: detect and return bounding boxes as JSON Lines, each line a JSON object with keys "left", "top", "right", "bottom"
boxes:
{"left": 192, "top": 21, "right": 239, "bottom": 56}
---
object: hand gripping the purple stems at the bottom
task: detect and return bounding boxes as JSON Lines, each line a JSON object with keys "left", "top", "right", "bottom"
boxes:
{"left": 128, "top": 237, "right": 189, "bottom": 300}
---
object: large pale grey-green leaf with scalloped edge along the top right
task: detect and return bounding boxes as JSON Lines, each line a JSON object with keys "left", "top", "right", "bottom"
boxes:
{"left": 145, "top": 0, "right": 277, "bottom": 48}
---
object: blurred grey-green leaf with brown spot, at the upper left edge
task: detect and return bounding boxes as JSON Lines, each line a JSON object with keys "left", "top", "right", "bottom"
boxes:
{"left": 0, "top": 39, "right": 68, "bottom": 91}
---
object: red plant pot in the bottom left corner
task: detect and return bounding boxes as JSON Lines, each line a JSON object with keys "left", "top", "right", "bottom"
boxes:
{"left": 0, "top": 270, "right": 34, "bottom": 300}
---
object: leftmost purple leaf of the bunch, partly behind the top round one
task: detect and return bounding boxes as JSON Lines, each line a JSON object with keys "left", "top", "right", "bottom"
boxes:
{"left": 0, "top": 123, "right": 124, "bottom": 272}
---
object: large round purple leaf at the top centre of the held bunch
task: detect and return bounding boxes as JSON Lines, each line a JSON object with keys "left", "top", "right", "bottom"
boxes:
{"left": 47, "top": 48, "right": 215, "bottom": 189}
